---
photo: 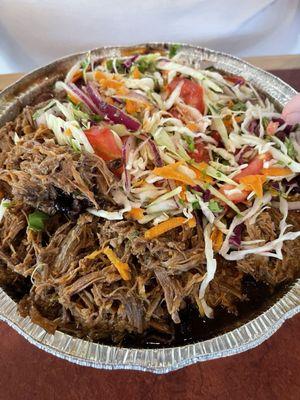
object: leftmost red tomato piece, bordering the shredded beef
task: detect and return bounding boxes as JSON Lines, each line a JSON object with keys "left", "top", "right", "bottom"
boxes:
{"left": 84, "top": 126, "right": 122, "bottom": 161}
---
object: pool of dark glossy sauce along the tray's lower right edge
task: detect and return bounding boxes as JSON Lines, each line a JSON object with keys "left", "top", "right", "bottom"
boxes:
{"left": 121, "top": 275, "right": 288, "bottom": 348}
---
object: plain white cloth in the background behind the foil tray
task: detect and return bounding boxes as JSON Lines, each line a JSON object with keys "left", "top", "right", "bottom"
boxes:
{"left": 0, "top": 0, "right": 300, "bottom": 73}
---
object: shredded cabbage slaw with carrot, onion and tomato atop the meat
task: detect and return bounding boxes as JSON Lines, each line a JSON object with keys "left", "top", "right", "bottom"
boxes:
{"left": 35, "top": 47, "right": 300, "bottom": 317}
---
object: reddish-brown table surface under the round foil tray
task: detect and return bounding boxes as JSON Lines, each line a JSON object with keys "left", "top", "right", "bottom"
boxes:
{"left": 0, "top": 56, "right": 300, "bottom": 400}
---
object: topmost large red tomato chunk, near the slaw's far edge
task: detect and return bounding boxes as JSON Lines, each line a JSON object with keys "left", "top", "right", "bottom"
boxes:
{"left": 168, "top": 77, "right": 205, "bottom": 114}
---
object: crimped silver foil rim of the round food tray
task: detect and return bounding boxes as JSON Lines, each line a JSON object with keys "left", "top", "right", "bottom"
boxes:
{"left": 0, "top": 43, "right": 300, "bottom": 373}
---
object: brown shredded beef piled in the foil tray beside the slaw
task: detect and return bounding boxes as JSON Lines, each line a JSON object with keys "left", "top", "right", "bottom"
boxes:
{"left": 0, "top": 107, "right": 300, "bottom": 343}
